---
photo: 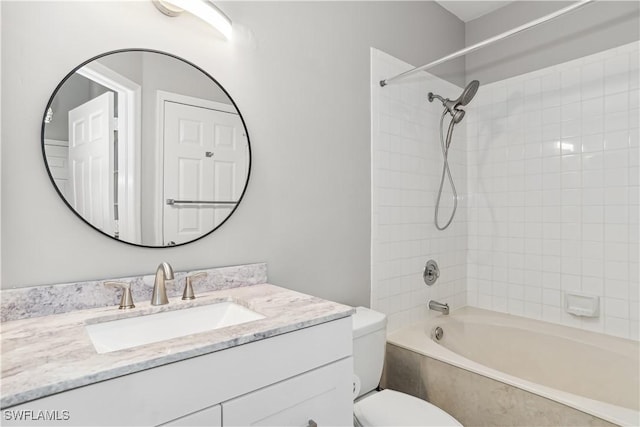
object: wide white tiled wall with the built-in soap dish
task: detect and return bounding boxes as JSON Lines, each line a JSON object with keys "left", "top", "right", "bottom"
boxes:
{"left": 465, "top": 43, "right": 640, "bottom": 339}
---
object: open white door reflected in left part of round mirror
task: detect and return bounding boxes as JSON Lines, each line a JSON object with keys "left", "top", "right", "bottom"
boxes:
{"left": 67, "top": 92, "right": 115, "bottom": 236}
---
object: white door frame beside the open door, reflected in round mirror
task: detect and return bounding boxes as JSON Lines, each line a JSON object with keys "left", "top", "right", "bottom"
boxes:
{"left": 77, "top": 61, "right": 142, "bottom": 242}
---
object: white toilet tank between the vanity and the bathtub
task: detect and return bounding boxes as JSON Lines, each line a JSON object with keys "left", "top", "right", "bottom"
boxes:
{"left": 352, "top": 307, "right": 387, "bottom": 397}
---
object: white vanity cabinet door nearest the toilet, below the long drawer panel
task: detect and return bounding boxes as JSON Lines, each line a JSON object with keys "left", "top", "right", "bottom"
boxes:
{"left": 222, "top": 357, "right": 353, "bottom": 427}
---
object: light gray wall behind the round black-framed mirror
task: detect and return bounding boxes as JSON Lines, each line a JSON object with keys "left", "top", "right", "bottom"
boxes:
{"left": 0, "top": 1, "right": 464, "bottom": 305}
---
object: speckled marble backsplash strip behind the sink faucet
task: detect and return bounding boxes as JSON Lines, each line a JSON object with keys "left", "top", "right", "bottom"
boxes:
{"left": 0, "top": 263, "right": 267, "bottom": 322}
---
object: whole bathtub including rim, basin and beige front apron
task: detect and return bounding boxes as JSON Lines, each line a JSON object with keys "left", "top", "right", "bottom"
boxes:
{"left": 383, "top": 307, "right": 640, "bottom": 426}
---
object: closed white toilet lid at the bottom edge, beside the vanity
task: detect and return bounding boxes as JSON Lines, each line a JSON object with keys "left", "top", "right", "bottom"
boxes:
{"left": 353, "top": 390, "right": 462, "bottom": 427}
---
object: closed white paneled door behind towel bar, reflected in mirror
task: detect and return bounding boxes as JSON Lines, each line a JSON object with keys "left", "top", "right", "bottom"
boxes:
{"left": 163, "top": 101, "right": 248, "bottom": 245}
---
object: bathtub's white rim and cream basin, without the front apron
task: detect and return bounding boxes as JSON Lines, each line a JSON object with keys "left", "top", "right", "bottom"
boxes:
{"left": 388, "top": 307, "right": 640, "bottom": 426}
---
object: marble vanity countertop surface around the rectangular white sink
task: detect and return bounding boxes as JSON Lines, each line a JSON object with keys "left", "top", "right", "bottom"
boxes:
{"left": 0, "top": 284, "right": 354, "bottom": 408}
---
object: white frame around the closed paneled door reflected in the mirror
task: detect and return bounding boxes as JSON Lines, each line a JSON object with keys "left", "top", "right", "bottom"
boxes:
{"left": 154, "top": 90, "right": 238, "bottom": 246}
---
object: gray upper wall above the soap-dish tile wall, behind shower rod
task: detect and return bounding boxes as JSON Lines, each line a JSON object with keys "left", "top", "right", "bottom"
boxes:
{"left": 465, "top": 1, "right": 640, "bottom": 84}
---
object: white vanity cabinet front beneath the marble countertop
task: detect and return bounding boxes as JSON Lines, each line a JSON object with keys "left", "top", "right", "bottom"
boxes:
{"left": 2, "top": 317, "right": 353, "bottom": 426}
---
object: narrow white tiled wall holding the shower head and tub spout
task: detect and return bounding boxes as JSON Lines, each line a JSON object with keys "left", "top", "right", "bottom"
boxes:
{"left": 371, "top": 49, "right": 467, "bottom": 332}
